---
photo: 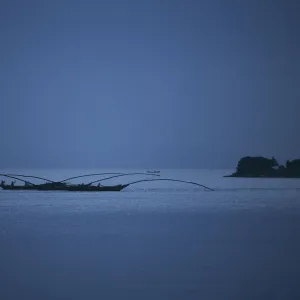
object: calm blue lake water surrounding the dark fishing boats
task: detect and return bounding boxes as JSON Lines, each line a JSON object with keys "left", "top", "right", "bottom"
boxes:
{"left": 0, "top": 170, "right": 300, "bottom": 300}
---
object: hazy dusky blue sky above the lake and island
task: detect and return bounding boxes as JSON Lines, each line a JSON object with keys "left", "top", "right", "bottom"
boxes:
{"left": 0, "top": 0, "right": 300, "bottom": 168}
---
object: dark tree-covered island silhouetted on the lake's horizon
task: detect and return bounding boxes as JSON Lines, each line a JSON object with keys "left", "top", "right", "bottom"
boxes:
{"left": 224, "top": 156, "right": 300, "bottom": 178}
